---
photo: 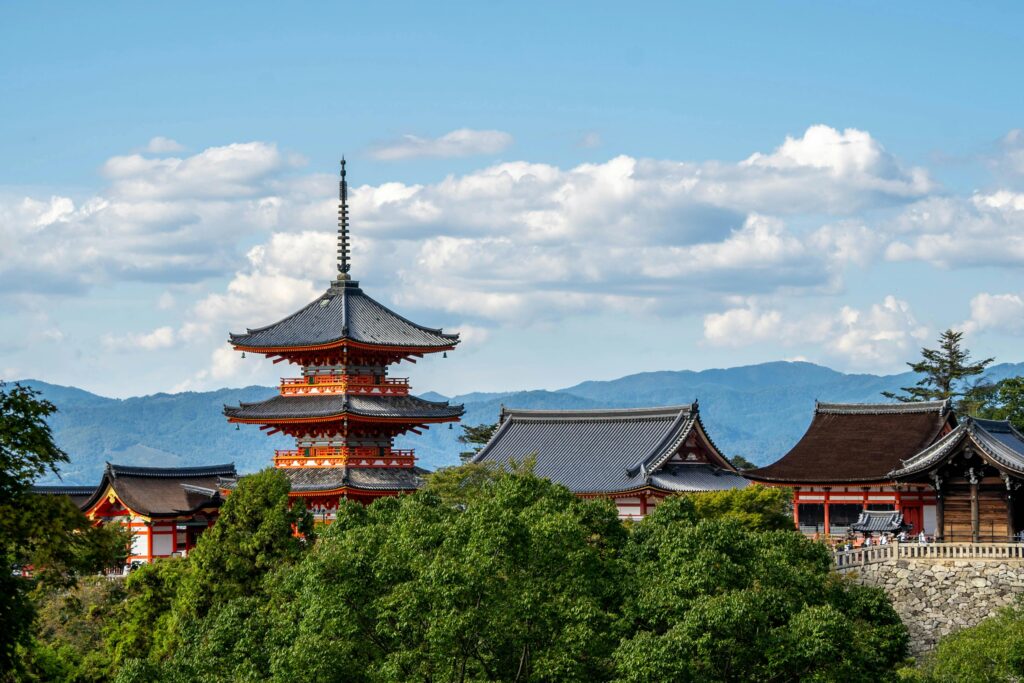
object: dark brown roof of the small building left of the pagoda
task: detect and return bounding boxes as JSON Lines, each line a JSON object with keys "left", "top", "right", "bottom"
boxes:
{"left": 81, "top": 463, "right": 238, "bottom": 517}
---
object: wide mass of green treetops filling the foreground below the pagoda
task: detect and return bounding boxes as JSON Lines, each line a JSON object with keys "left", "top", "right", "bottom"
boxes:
{"left": 18, "top": 463, "right": 906, "bottom": 683}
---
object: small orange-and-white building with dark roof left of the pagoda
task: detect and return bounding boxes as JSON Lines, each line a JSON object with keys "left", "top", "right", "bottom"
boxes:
{"left": 81, "top": 463, "right": 238, "bottom": 562}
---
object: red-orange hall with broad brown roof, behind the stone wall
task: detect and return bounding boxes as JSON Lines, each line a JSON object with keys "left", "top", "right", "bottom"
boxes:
{"left": 743, "top": 400, "right": 956, "bottom": 533}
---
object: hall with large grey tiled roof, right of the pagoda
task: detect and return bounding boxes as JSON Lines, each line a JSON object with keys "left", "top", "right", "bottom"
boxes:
{"left": 473, "top": 402, "right": 749, "bottom": 519}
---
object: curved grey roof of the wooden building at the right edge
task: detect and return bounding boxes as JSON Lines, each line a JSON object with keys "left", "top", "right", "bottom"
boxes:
{"left": 889, "top": 418, "right": 1024, "bottom": 479}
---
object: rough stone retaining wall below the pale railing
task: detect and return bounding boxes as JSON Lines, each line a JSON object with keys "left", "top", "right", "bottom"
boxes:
{"left": 844, "top": 558, "right": 1024, "bottom": 654}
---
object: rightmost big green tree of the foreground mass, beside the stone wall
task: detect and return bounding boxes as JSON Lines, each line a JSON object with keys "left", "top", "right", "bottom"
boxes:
{"left": 614, "top": 497, "right": 907, "bottom": 682}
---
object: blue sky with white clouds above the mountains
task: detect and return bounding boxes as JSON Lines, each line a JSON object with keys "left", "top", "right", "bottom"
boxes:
{"left": 0, "top": 1, "right": 1024, "bottom": 396}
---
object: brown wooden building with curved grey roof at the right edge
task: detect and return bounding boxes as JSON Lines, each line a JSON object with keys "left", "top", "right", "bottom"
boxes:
{"left": 889, "top": 418, "right": 1024, "bottom": 543}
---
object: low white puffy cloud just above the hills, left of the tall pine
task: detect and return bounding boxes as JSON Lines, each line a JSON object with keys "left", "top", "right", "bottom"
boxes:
{"left": 703, "top": 295, "right": 928, "bottom": 370}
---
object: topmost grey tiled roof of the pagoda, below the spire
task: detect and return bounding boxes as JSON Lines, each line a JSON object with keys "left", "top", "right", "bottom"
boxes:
{"left": 230, "top": 282, "right": 459, "bottom": 348}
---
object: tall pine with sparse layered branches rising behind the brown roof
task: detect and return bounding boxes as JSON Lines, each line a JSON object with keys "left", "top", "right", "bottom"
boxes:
{"left": 882, "top": 330, "right": 994, "bottom": 402}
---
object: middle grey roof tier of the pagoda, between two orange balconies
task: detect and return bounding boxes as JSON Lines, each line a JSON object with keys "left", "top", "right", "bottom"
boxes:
{"left": 224, "top": 394, "right": 463, "bottom": 420}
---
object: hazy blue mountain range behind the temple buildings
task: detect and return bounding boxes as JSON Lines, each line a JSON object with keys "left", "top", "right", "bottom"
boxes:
{"left": 22, "top": 361, "right": 1024, "bottom": 484}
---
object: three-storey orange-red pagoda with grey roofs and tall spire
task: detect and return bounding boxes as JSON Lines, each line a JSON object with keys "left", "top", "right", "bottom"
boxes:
{"left": 224, "top": 159, "right": 463, "bottom": 521}
